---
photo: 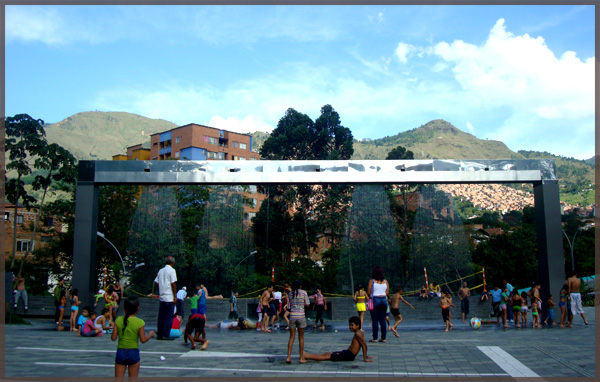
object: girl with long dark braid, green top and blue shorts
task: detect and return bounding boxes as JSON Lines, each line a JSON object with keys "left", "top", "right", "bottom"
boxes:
{"left": 110, "top": 297, "right": 154, "bottom": 380}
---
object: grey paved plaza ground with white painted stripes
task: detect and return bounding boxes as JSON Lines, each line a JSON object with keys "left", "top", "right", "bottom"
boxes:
{"left": 4, "top": 308, "right": 595, "bottom": 380}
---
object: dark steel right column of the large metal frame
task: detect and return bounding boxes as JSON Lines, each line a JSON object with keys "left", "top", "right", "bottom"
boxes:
{"left": 533, "top": 180, "right": 566, "bottom": 317}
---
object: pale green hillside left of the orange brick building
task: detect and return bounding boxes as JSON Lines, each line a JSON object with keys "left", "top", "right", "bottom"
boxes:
{"left": 44, "top": 111, "right": 177, "bottom": 160}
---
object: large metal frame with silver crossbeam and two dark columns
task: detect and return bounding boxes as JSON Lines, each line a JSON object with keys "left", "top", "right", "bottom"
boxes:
{"left": 72, "top": 159, "right": 565, "bottom": 304}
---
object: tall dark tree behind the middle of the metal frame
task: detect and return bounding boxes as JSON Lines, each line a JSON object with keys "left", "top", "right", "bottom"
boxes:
{"left": 255, "top": 105, "right": 354, "bottom": 280}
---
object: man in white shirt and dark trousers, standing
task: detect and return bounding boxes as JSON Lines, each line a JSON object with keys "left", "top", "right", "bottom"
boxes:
{"left": 154, "top": 256, "right": 177, "bottom": 340}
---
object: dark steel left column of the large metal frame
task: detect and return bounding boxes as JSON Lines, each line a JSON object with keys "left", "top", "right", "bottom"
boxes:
{"left": 72, "top": 161, "right": 99, "bottom": 306}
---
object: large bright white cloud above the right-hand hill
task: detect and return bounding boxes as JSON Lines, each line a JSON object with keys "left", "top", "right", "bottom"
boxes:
{"left": 434, "top": 19, "right": 595, "bottom": 119}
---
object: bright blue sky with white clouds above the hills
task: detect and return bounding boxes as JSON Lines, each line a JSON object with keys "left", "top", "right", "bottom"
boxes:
{"left": 5, "top": 5, "right": 596, "bottom": 159}
